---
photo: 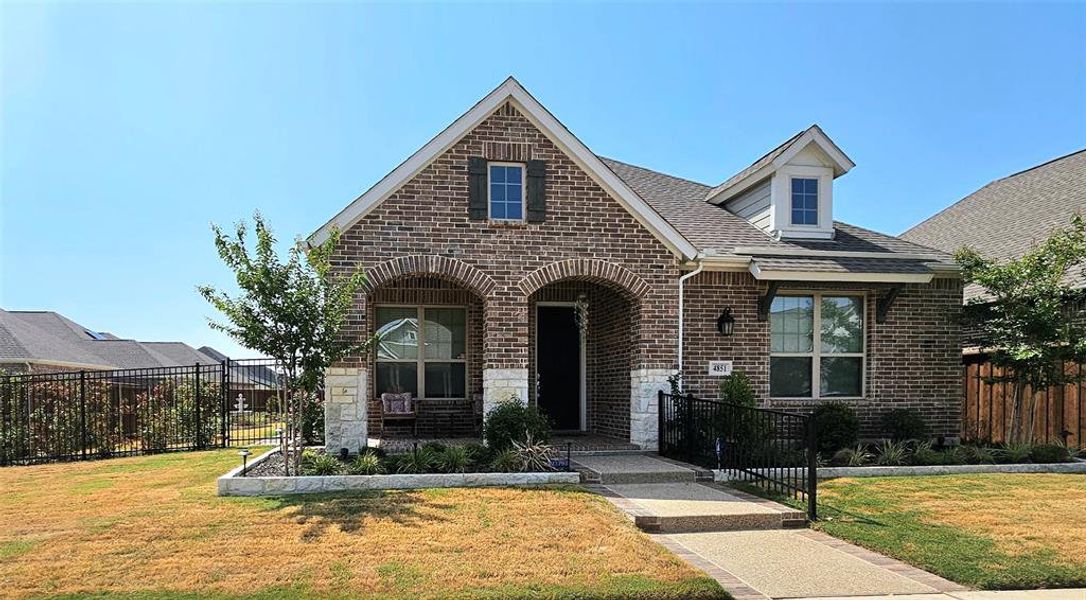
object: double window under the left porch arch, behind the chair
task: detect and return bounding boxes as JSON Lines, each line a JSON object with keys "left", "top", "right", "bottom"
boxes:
{"left": 376, "top": 307, "right": 467, "bottom": 399}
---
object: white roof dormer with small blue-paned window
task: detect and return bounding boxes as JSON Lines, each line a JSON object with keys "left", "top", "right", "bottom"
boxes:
{"left": 706, "top": 125, "right": 856, "bottom": 239}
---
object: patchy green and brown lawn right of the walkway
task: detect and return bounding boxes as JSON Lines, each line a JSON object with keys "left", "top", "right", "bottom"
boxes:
{"left": 816, "top": 474, "right": 1086, "bottom": 589}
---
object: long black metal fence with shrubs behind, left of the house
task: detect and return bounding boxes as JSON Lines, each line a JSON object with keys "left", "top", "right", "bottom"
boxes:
{"left": 0, "top": 359, "right": 295, "bottom": 465}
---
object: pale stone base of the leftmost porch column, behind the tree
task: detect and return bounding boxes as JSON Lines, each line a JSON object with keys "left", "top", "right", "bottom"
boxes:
{"left": 325, "top": 366, "right": 369, "bottom": 453}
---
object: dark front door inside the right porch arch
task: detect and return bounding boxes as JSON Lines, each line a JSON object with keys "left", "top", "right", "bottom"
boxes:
{"left": 535, "top": 307, "right": 581, "bottom": 429}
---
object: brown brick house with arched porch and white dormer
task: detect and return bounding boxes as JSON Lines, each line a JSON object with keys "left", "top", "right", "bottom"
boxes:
{"left": 310, "top": 78, "right": 961, "bottom": 450}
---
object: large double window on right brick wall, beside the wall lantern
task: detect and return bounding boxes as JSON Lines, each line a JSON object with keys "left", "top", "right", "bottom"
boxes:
{"left": 769, "top": 293, "right": 864, "bottom": 398}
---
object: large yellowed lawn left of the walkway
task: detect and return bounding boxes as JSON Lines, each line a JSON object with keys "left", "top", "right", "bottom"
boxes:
{"left": 0, "top": 450, "right": 727, "bottom": 600}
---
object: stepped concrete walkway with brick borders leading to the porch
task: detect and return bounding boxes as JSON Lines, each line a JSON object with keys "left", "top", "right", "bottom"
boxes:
{"left": 590, "top": 454, "right": 981, "bottom": 600}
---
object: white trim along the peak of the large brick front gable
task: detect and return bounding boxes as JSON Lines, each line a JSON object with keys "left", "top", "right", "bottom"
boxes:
{"left": 308, "top": 77, "right": 697, "bottom": 259}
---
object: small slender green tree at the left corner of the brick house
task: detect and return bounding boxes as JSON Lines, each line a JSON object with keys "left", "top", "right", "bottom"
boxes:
{"left": 198, "top": 213, "right": 371, "bottom": 475}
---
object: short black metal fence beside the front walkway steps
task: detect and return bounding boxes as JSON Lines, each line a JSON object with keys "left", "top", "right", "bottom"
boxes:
{"left": 658, "top": 391, "right": 818, "bottom": 520}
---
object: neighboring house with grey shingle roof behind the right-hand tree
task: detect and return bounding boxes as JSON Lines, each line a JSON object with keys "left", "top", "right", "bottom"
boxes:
{"left": 901, "top": 150, "right": 1086, "bottom": 354}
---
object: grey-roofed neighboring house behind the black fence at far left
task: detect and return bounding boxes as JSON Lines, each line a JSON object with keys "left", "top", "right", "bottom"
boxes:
{"left": 0, "top": 309, "right": 219, "bottom": 373}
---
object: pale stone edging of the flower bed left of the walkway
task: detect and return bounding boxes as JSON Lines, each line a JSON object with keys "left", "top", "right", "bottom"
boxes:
{"left": 217, "top": 449, "right": 581, "bottom": 496}
